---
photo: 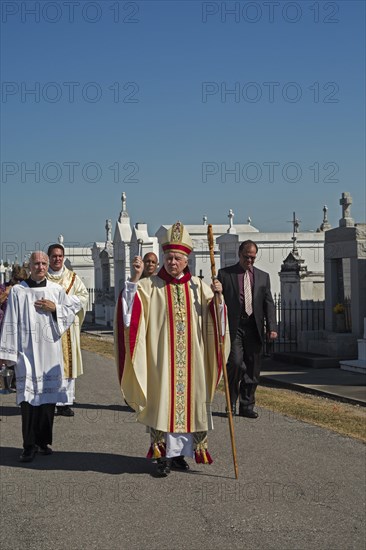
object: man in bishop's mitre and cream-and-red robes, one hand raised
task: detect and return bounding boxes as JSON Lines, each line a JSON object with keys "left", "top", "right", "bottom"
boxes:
{"left": 114, "top": 222, "right": 230, "bottom": 477}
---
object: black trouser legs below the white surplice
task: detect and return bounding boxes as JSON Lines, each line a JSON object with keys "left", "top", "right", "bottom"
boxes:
{"left": 20, "top": 401, "right": 55, "bottom": 449}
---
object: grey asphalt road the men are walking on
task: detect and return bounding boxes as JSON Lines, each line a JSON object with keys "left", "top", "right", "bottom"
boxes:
{"left": 0, "top": 352, "right": 366, "bottom": 550}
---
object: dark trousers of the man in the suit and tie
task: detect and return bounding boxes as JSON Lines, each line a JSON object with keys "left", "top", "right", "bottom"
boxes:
{"left": 227, "top": 317, "right": 262, "bottom": 411}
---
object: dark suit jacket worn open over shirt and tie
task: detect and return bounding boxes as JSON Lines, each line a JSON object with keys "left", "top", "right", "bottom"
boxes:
{"left": 218, "top": 262, "right": 277, "bottom": 343}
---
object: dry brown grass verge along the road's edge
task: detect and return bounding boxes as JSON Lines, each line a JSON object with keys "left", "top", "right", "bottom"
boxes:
{"left": 81, "top": 333, "right": 366, "bottom": 442}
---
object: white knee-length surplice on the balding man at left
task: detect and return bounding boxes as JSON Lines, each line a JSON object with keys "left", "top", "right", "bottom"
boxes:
{"left": 0, "top": 281, "right": 81, "bottom": 406}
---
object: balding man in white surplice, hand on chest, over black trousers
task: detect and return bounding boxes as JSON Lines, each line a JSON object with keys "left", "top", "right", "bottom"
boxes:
{"left": 0, "top": 252, "right": 81, "bottom": 462}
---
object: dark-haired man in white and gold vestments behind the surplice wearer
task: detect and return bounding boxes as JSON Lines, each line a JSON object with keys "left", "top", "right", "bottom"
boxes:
{"left": 47, "top": 243, "right": 89, "bottom": 416}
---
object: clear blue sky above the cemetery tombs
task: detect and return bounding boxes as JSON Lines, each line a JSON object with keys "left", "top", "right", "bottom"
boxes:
{"left": 1, "top": 0, "right": 365, "bottom": 260}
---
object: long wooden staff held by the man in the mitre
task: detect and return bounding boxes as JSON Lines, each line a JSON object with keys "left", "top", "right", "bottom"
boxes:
{"left": 207, "top": 224, "right": 239, "bottom": 479}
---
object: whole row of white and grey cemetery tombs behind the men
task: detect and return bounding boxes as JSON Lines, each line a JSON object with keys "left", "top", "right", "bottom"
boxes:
{"left": 0, "top": 193, "right": 366, "bottom": 370}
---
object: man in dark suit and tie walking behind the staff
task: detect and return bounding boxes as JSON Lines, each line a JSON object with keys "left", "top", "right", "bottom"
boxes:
{"left": 218, "top": 240, "right": 277, "bottom": 418}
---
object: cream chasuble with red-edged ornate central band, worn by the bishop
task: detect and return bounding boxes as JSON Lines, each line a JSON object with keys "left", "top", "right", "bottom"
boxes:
{"left": 115, "top": 270, "right": 230, "bottom": 461}
